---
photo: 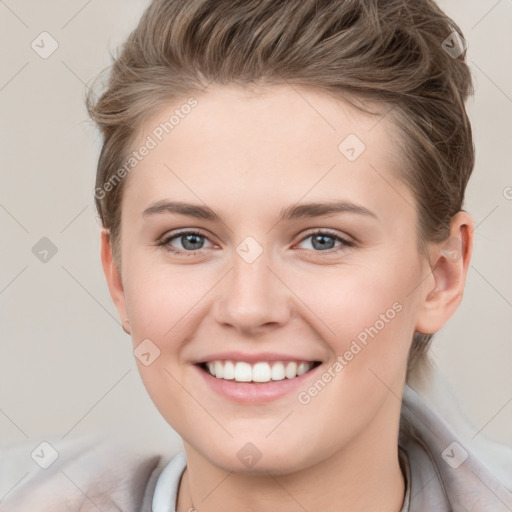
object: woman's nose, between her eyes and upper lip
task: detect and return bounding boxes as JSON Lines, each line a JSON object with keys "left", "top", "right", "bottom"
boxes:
{"left": 214, "top": 248, "right": 293, "bottom": 335}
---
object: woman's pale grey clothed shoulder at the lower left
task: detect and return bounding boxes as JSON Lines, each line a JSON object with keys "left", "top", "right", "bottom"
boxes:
{"left": 0, "top": 435, "right": 173, "bottom": 512}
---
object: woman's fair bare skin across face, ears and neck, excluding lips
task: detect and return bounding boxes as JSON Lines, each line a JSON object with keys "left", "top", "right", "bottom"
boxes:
{"left": 102, "top": 86, "right": 473, "bottom": 512}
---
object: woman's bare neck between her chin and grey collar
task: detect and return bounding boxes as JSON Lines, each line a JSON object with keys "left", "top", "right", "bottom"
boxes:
{"left": 177, "top": 396, "right": 405, "bottom": 512}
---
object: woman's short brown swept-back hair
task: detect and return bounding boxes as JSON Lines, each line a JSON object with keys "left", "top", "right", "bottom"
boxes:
{"left": 86, "top": 0, "right": 474, "bottom": 371}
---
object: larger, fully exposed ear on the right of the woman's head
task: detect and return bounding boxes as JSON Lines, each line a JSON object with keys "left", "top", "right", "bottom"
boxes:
{"left": 416, "top": 211, "right": 475, "bottom": 334}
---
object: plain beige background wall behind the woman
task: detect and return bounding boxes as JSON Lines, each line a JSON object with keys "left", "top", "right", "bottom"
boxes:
{"left": 0, "top": 0, "right": 512, "bottom": 464}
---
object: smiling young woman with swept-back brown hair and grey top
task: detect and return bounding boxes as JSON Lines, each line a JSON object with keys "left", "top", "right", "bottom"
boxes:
{"left": 2, "top": 0, "right": 512, "bottom": 512}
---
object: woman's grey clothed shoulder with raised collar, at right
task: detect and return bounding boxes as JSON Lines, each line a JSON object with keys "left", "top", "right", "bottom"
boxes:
{"left": 400, "top": 386, "right": 512, "bottom": 512}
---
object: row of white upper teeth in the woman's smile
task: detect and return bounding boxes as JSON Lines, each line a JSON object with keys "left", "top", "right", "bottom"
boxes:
{"left": 206, "top": 361, "right": 313, "bottom": 382}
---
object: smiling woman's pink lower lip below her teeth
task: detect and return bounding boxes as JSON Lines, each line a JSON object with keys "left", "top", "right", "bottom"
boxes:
{"left": 194, "top": 365, "right": 322, "bottom": 404}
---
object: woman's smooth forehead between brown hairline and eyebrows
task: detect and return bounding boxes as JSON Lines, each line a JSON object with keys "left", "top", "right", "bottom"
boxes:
{"left": 123, "top": 86, "right": 409, "bottom": 218}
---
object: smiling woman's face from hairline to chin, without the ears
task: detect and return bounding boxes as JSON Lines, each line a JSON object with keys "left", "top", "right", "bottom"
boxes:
{"left": 105, "top": 86, "right": 444, "bottom": 473}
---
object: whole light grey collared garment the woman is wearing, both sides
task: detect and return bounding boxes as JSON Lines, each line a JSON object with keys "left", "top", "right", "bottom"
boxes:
{"left": 0, "top": 386, "right": 512, "bottom": 512}
